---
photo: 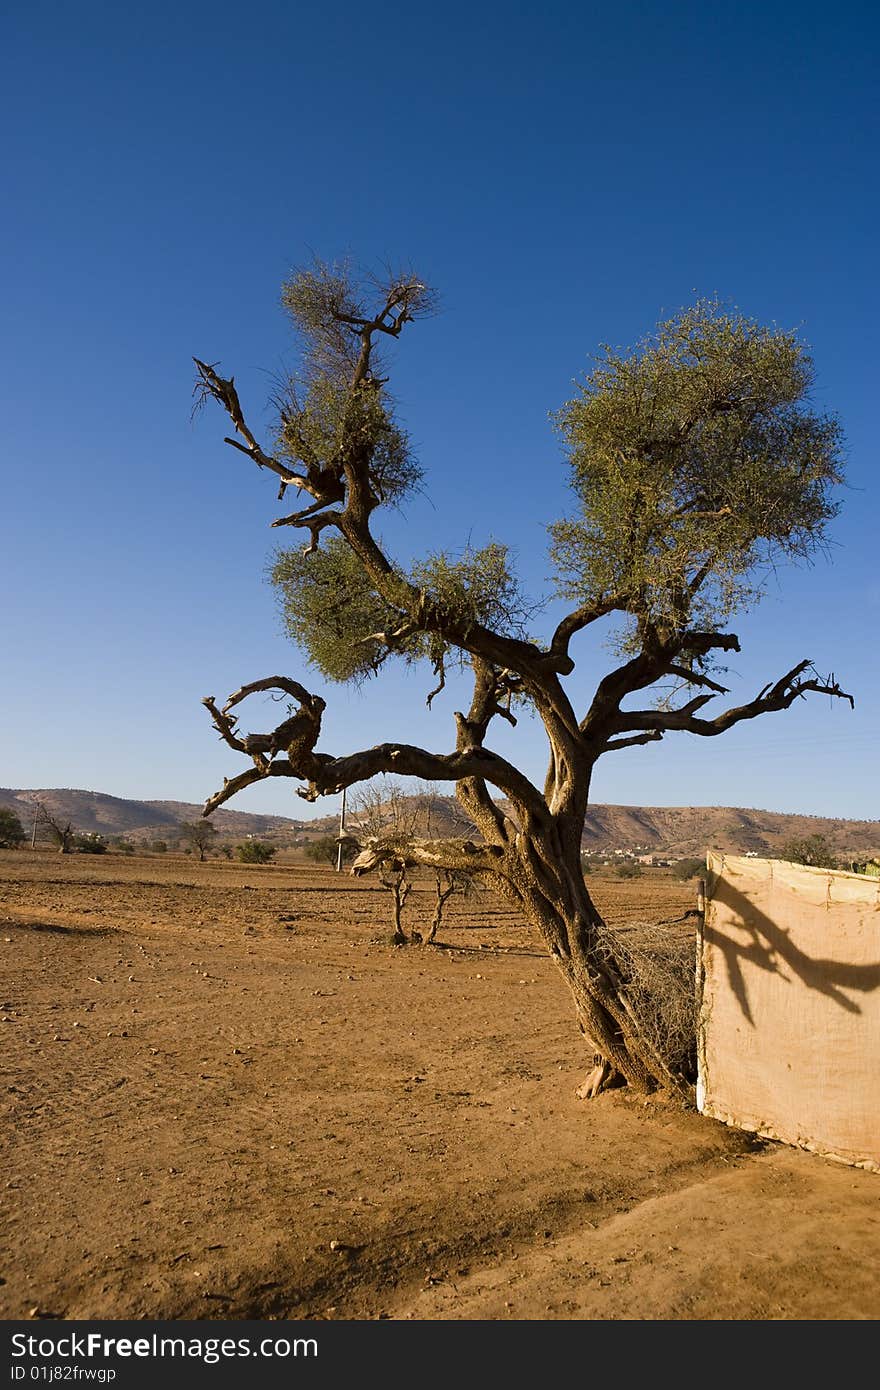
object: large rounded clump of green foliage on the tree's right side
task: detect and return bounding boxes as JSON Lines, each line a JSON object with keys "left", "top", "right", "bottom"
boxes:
{"left": 551, "top": 300, "right": 842, "bottom": 635}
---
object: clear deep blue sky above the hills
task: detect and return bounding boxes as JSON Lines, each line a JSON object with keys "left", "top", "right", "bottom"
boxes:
{"left": 0, "top": 0, "right": 880, "bottom": 819}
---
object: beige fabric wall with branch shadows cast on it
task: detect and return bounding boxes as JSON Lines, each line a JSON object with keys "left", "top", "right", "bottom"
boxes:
{"left": 698, "top": 855, "right": 880, "bottom": 1172}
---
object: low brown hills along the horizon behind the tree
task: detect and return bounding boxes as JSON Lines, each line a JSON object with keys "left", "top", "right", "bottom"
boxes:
{"left": 0, "top": 787, "right": 880, "bottom": 859}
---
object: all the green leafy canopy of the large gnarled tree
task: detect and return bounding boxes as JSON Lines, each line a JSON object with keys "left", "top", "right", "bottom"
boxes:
{"left": 270, "top": 278, "right": 842, "bottom": 706}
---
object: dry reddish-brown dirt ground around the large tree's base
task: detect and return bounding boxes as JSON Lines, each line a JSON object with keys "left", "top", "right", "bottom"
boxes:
{"left": 0, "top": 851, "right": 880, "bottom": 1321}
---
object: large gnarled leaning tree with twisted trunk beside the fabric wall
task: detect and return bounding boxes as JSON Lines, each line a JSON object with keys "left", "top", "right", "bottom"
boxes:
{"left": 196, "top": 264, "right": 849, "bottom": 1097}
